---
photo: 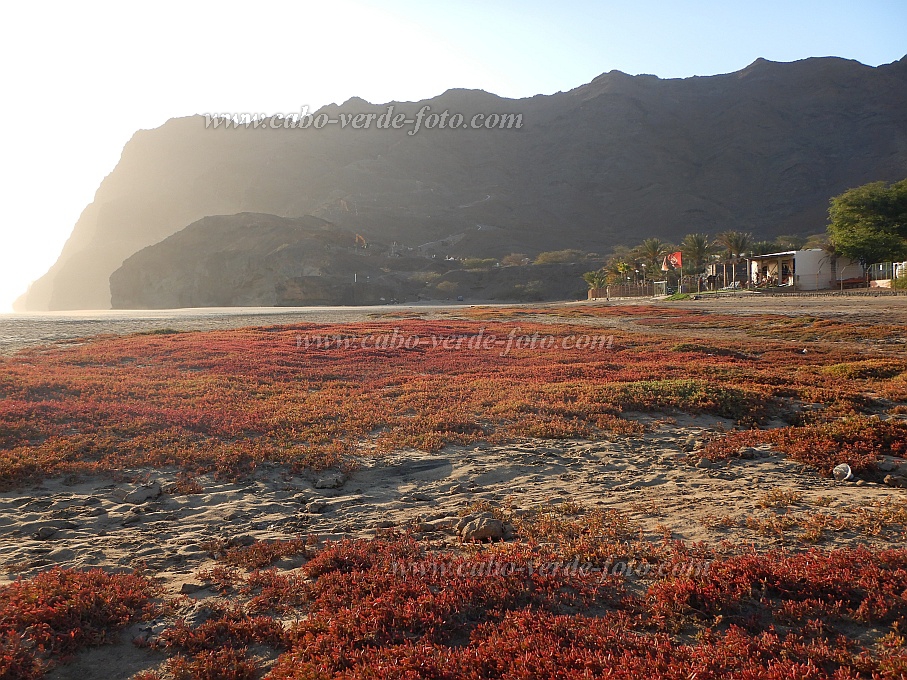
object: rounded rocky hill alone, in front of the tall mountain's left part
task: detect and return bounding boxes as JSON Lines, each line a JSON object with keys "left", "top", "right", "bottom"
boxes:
{"left": 110, "top": 213, "right": 431, "bottom": 309}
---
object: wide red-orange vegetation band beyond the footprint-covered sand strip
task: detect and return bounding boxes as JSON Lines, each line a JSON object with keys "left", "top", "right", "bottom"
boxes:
{"left": 0, "top": 316, "right": 907, "bottom": 486}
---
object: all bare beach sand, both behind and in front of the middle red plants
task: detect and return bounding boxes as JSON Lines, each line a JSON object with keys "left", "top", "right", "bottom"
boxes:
{"left": 0, "top": 297, "right": 907, "bottom": 680}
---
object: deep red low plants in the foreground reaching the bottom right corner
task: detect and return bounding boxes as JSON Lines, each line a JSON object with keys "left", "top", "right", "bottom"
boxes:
{"left": 141, "top": 538, "right": 907, "bottom": 680}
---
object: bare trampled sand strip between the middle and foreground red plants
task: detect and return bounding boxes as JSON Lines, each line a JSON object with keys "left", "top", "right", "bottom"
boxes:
{"left": 0, "top": 414, "right": 904, "bottom": 593}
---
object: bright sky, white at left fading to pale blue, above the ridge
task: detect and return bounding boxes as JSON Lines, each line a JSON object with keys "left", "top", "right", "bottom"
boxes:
{"left": 0, "top": 0, "right": 907, "bottom": 312}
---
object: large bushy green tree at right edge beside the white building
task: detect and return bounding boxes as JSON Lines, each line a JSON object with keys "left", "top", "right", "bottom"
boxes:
{"left": 828, "top": 179, "right": 907, "bottom": 270}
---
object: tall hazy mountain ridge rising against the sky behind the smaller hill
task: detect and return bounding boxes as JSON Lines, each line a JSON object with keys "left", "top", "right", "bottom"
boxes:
{"left": 20, "top": 57, "right": 907, "bottom": 310}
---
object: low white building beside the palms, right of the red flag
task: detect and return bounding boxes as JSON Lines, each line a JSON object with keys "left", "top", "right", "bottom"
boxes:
{"left": 749, "top": 248, "right": 863, "bottom": 290}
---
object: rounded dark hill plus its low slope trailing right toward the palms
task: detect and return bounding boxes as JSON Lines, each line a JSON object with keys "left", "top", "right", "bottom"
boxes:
{"left": 110, "top": 213, "right": 594, "bottom": 309}
